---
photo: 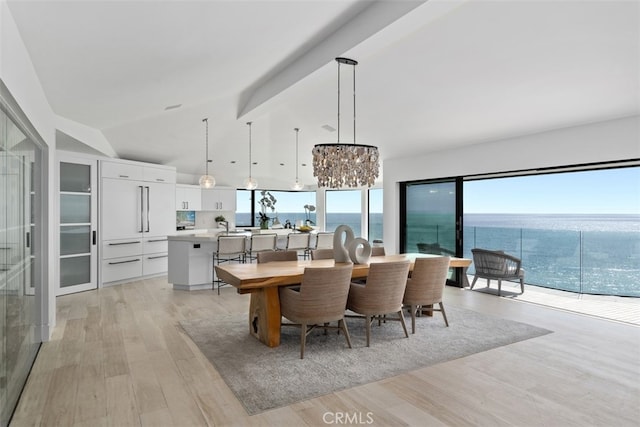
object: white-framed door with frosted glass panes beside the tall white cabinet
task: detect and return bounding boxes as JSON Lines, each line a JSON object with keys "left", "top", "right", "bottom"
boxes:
{"left": 57, "top": 155, "right": 98, "bottom": 295}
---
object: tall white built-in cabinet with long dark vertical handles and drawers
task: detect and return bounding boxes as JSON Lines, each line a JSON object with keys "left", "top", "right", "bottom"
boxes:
{"left": 100, "top": 161, "right": 176, "bottom": 284}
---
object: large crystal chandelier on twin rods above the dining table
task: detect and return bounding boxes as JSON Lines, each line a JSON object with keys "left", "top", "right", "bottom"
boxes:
{"left": 312, "top": 58, "right": 380, "bottom": 188}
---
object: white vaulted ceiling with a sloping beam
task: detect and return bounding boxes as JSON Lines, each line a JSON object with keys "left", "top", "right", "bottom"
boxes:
{"left": 8, "top": 0, "right": 640, "bottom": 189}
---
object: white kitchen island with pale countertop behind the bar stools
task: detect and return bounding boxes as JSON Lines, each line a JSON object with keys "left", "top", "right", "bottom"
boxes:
{"left": 168, "top": 229, "right": 302, "bottom": 291}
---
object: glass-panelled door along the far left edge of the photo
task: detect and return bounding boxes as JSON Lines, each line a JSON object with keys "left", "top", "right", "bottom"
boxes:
{"left": 0, "top": 103, "right": 41, "bottom": 425}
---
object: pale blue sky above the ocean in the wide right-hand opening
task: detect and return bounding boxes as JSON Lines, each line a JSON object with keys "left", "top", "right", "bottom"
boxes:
{"left": 463, "top": 167, "right": 640, "bottom": 215}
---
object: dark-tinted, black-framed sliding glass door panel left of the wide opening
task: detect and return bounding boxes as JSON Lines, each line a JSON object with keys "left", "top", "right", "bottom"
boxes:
{"left": 400, "top": 178, "right": 462, "bottom": 284}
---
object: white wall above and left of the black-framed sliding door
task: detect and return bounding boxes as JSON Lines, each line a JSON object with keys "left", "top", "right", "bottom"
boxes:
{"left": 383, "top": 116, "right": 640, "bottom": 253}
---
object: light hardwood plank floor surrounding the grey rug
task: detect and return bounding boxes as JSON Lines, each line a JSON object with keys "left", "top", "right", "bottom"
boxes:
{"left": 11, "top": 277, "right": 640, "bottom": 426}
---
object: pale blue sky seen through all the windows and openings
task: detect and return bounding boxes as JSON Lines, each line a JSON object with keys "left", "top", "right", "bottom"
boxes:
{"left": 238, "top": 167, "right": 640, "bottom": 215}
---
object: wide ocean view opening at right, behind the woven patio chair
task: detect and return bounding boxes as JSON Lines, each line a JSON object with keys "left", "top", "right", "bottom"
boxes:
{"left": 464, "top": 167, "right": 640, "bottom": 297}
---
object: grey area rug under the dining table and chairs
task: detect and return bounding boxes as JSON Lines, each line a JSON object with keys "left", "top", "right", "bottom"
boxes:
{"left": 180, "top": 305, "right": 550, "bottom": 415}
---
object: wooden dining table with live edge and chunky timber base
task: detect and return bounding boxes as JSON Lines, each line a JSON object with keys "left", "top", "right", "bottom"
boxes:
{"left": 215, "top": 254, "right": 471, "bottom": 347}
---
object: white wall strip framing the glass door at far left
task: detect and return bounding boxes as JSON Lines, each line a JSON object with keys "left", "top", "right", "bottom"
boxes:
{"left": 0, "top": 1, "right": 57, "bottom": 341}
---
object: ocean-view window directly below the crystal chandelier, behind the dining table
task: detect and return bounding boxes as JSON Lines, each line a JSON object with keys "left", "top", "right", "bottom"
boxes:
{"left": 325, "top": 190, "right": 362, "bottom": 237}
